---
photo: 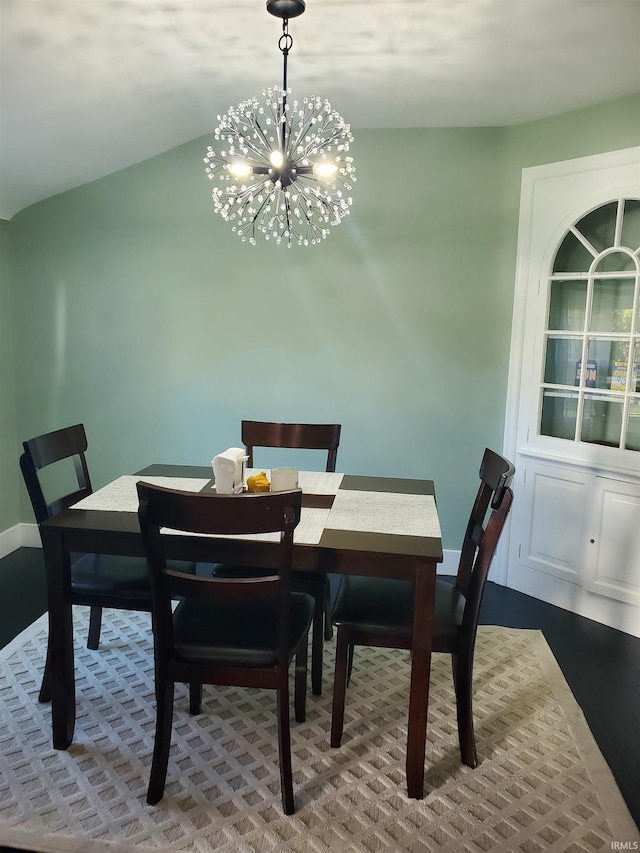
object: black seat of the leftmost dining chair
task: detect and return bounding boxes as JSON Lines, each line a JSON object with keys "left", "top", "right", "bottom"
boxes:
{"left": 71, "top": 554, "right": 151, "bottom": 602}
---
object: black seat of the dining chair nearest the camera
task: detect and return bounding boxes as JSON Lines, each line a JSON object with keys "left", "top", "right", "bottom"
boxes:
{"left": 173, "top": 593, "right": 314, "bottom": 667}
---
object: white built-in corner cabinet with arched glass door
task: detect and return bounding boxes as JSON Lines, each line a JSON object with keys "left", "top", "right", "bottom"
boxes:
{"left": 504, "top": 149, "right": 640, "bottom": 636}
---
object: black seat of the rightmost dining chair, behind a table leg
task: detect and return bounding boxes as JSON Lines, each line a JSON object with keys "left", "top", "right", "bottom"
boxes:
{"left": 331, "top": 575, "right": 464, "bottom": 639}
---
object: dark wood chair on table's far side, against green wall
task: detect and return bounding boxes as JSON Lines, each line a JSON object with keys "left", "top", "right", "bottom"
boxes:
{"left": 214, "top": 421, "right": 341, "bottom": 695}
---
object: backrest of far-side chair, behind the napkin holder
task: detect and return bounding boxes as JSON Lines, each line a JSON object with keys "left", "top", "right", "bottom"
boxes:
{"left": 242, "top": 421, "right": 341, "bottom": 471}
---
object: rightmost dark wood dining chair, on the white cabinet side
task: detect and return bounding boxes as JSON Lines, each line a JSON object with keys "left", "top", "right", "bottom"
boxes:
{"left": 331, "top": 448, "right": 515, "bottom": 767}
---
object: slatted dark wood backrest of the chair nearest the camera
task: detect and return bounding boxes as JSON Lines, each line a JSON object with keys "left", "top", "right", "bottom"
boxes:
{"left": 137, "top": 482, "right": 302, "bottom": 662}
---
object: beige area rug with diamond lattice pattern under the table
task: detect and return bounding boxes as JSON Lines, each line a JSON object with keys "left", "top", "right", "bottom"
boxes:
{"left": 0, "top": 608, "right": 640, "bottom": 853}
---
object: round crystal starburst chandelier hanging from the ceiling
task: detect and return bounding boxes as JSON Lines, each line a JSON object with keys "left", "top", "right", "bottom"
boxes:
{"left": 204, "top": 0, "right": 356, "bottom": 248}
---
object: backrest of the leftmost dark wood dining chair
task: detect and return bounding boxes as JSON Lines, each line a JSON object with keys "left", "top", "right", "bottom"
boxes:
{"left": 20, "top": 424, "right": 93, "bottom": 524}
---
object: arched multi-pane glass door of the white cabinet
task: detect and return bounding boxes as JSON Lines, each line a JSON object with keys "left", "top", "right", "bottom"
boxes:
{"left": 538, "top": 198, "right": 640, "bottom": 453}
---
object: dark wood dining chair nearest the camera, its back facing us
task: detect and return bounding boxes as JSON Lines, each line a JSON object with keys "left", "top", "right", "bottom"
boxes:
{"left": 138, "top": 483, "right": 313, "bottom": 814}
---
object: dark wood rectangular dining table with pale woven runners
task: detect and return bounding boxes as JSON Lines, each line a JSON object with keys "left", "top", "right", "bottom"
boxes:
{"left": 40, "top": 465, "right": 442, "bottom": 799}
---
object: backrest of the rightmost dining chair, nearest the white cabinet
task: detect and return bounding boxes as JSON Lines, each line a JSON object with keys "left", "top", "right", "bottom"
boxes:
{"left": 456, "top": 448, "right": 515, "bottom": 598}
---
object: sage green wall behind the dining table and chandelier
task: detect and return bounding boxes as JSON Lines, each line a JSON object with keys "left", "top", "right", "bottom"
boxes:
{"left": 5, "top": 93, "right": 640, "bottom": 548}
